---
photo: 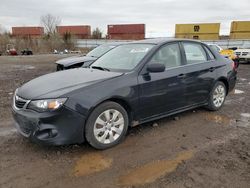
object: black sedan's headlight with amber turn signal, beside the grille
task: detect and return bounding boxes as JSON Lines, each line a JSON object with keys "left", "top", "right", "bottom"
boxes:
{"left": 27, "top": 98, "right": 67, "bottom": 112}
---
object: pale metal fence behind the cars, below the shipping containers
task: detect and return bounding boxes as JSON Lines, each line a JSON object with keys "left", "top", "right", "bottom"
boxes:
{"left": 76, "top": 38, "right": 250, "bottom": 49}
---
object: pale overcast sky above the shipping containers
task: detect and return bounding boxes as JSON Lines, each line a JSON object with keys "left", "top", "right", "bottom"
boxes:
{"left": 0, "top": 0, "right": 250, "bottom": 37}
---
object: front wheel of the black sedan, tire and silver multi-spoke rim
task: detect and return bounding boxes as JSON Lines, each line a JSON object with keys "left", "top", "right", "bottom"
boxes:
{"left": 85, "top": 101, "right": 129, "bottom": 149}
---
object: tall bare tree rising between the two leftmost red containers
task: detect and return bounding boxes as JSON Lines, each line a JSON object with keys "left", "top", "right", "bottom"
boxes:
{"left": 41, "top": 14, "right": 61, "bottom": 35}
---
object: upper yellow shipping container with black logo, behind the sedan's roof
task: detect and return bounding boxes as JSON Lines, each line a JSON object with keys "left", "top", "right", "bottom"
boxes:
{"left": 175, "top": 23, "right": 220, "bottom": 34}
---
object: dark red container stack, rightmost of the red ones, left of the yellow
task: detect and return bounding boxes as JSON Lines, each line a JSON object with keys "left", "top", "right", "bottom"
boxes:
{"left": 107, "top": 24, "right": 145, "bottom": 40}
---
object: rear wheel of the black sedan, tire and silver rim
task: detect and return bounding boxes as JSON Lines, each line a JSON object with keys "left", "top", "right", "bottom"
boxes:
{"left": 207, "top": 81, "right": 227, "bottom": 111}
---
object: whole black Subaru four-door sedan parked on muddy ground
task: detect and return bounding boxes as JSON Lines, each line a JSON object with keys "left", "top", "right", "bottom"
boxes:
{"left": 13, "top": 39, "right": 237, "bottom": 149}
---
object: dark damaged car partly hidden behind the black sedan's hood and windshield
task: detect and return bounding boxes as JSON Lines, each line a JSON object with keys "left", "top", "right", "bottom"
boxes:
{"left": 56, "top": 42, "right": 123, "bottom": 71}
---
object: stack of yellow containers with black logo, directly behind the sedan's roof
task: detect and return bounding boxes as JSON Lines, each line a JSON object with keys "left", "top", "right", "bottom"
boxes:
{"left": 175, "top": 23, "right": 220, "bottom": 40}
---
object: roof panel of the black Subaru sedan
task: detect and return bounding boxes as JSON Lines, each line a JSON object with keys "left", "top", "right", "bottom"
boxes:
{"left": 127, "top": 38, "right": 201, "bottom": 45}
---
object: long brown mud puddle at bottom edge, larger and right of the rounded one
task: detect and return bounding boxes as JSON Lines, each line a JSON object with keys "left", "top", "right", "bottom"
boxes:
{"left": 118, "top": 151, "right": 194, "bottom": 186}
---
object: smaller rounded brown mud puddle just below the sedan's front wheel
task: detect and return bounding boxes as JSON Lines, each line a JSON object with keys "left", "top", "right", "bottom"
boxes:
{"left": 72, "top": 152, "right": 112, "bottom": 177}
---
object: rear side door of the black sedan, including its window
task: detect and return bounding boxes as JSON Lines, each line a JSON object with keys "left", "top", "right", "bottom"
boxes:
{"left": 182, "top": 42, "right": 216, "bottom": 106}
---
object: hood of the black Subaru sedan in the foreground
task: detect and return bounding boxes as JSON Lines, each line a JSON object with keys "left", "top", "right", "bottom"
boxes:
{"left": 17, "top": 68, "right": 123, "bottom": 100}
